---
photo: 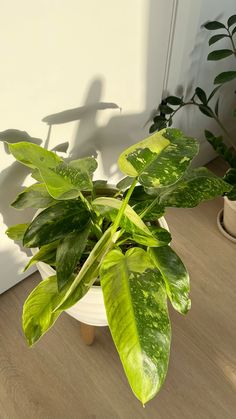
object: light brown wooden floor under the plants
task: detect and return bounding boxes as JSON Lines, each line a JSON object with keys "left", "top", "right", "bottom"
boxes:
{"left": 0, "top": 162, "right": 236, "bottom": 419}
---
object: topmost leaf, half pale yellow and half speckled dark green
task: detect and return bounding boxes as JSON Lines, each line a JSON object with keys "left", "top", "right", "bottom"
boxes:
{"left": 118, "top": 128, "right": 199, "bottom": 187}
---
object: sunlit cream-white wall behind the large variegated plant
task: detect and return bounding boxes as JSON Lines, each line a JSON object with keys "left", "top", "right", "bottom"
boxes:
{"left": 0, "top": 0, "right": 173, "bottom": 292}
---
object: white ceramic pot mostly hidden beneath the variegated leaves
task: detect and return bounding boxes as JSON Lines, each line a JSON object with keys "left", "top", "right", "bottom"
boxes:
{"left": 31, "top": 217, "right": 169, "bottom": 326}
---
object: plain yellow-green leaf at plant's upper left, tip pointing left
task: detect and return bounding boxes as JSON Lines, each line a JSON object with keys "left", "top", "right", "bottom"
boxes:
{"left": 8, "top": 141, "right": 62, "bottom": 169}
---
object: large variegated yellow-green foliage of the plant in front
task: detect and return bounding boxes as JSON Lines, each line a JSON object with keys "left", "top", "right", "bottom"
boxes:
{"left": 7, "top": 129, "right": 231, "bottom": 404}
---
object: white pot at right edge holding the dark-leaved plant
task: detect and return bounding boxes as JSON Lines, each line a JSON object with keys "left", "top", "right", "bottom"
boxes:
{"left": 217, "top": 196, "right": 236, "bottom": 243}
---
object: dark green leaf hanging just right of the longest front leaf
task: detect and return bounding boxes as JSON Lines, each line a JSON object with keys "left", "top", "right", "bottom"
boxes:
{"left": 149, "top": 246, "right": 191, "bottom": 314}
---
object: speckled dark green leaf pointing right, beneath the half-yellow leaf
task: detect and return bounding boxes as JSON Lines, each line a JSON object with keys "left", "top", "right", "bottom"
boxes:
{"left": 148, "top": 167, "right": 230, "bottom": 208}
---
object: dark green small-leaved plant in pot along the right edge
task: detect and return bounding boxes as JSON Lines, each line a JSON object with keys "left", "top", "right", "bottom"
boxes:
{"left": 150, "top": 15, "right": 236, "bottom": 242}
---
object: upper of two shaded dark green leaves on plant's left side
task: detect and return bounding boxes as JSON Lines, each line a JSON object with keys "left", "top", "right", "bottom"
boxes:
{"left": 23, "top": 200, "right": 90, "bottom": 247}
